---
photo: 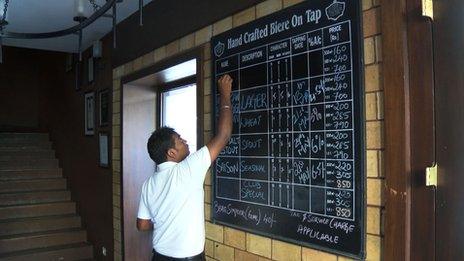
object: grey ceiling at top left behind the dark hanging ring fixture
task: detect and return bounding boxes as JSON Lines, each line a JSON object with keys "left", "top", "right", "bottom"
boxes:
{"left": 0, "top": 0, "right": 152, "bottom": 53}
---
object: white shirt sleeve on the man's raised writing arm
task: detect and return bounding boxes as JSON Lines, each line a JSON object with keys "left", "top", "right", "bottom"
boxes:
{"left": 176, "top": 146, "right": 211, "bottom": 185}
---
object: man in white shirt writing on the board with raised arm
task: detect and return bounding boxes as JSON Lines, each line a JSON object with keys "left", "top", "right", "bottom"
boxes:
{"left": 137, "top": 75, "right": 232, "bottom": 261}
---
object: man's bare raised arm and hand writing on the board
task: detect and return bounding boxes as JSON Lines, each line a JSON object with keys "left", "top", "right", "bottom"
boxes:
{"left": 206, "top": 74, "right": 233, "bottom": 161}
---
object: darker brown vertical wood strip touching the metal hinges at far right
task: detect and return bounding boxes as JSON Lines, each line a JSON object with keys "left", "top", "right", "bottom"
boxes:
{"left": 407, "top": 0, "right": 435, "bottom": 261}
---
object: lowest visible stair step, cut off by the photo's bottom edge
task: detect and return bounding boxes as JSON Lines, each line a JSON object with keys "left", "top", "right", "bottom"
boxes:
{"left": 0, "top": 243, "right": 93, "bottom": 261}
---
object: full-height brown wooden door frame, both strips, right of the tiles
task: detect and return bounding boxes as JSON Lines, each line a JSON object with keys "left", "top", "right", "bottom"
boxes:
{"left": 381, "top": 0, "right": 435, "bottom": 260}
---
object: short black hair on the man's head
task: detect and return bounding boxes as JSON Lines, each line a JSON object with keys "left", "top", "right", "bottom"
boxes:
{"left": 147, "top": 127, "right": 177, "bottom": 164}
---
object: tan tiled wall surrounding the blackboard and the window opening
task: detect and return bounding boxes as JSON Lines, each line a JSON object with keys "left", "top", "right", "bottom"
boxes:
{"left": 112, "top": 0, "right": 384, "bottom": 261}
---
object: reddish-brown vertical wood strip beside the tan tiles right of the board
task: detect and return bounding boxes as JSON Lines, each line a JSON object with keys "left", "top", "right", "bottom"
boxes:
{"left": 381, "top": 0, "right": 411, "bottom": 260}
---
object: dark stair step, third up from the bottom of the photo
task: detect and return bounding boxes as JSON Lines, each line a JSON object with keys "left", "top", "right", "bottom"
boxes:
{"left": 0, "top": 215, "right": 81, "bottom": 237}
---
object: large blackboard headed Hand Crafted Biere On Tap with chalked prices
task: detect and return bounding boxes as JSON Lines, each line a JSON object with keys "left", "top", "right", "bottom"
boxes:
{"left": 211, "top": 0, "right": 365, "bottom": 258}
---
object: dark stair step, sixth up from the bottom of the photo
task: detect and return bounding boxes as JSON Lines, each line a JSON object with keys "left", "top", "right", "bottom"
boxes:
{"left": 0, "top": 178, "right": 66, "bottom": 193}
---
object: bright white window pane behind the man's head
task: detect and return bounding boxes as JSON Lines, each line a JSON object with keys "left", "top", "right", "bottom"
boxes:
{"left": 161, "top": 84, "right": 197, "bottom": 152}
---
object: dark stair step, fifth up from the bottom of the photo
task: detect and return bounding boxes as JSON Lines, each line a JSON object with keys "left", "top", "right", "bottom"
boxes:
{"left": 0, "top": 190, "right": 71, "bottom": 206}
